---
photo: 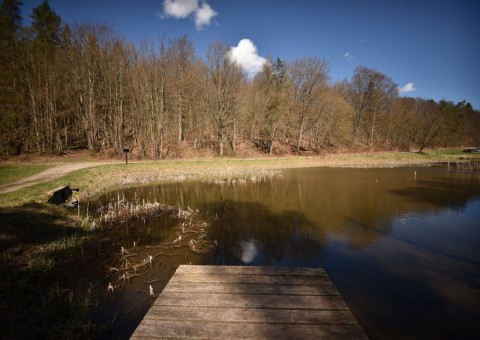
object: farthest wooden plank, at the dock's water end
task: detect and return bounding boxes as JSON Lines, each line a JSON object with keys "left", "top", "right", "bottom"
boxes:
{"left": 176, "top": 265, "right": 327, "bottom": 277}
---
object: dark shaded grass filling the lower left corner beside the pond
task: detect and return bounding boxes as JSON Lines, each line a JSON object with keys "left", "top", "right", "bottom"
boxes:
{"left": 0, "top": 203, "right": 102, "bottom": 339}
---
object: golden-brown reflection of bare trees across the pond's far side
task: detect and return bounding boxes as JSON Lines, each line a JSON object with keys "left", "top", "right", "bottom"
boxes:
{"left": 113, "top": 169, "right": 479, "bottom": 247}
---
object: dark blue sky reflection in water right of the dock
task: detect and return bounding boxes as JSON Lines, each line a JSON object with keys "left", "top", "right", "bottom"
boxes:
{"left": 326, "top": 200, "right": 480, "bottom": 339}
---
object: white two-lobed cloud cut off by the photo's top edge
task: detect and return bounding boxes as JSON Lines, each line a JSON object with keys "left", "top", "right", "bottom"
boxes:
{"left": 157, "top": 0, "right": 218, "bottom": 30}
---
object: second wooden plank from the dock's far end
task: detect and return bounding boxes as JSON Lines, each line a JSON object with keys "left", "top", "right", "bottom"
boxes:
{"left": 170, "top": 272, "right": 332, "bottom": 285}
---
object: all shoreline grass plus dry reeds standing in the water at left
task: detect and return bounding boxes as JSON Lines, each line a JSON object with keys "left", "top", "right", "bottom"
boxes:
{"left": 0, "top": 150, "right": 480, "bottom": 338}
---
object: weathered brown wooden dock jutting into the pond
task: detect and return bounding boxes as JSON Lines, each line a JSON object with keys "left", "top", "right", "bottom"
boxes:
{"left": 132, "top": 265, "right": 367, "bottom": 339}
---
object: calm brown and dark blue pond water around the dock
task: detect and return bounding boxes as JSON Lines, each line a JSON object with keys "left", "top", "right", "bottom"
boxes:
{"left": 91, "top": 167, "right": 480, "bottom": 339}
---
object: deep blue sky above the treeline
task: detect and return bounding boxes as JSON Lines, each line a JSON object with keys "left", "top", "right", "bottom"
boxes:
{"left": 22, "top": 0, "right": 480, "bottom": 109}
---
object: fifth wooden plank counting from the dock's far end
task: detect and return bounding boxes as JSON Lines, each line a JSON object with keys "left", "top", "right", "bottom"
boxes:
{"left": 141, "top": 306, "right": 358, "bottom": 325}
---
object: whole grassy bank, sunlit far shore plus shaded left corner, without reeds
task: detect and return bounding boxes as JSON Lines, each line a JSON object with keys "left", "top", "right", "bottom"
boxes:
{"left": 0, "top": 150, "right": 480, "bottom": 338}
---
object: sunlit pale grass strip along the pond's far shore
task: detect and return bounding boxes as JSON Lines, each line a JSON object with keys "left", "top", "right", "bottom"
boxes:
{"left": 0, "top": 150, "right": 480, "bottom": 206}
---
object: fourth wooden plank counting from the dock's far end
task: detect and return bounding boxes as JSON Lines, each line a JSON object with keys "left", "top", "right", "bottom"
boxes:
{"left": 151, "top": 293, "right": 348, "bottom": 310}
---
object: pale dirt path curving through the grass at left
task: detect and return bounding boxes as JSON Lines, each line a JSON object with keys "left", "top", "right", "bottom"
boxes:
{"left": 0, "top": 162, "right": 109, "bottom": 194}
